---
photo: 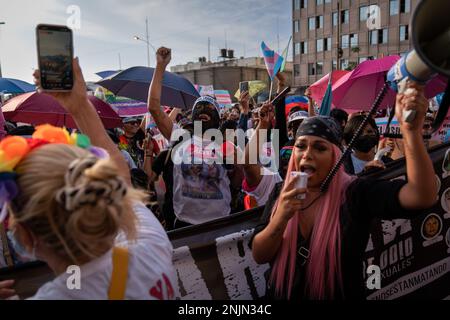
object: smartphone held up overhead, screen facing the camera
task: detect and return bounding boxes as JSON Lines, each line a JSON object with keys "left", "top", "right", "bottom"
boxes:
{"left": 36, "top": 25, "right": 73, "bottom": 91}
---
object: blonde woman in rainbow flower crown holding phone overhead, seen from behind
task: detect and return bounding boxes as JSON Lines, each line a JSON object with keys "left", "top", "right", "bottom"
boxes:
{"left": 0, "top": 25, "right": 177, "bottom": 300}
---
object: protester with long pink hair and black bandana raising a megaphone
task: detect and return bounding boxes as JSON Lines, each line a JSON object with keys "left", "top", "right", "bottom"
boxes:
{"left": 250, "top": 82, "right": 437, "bottom": 300}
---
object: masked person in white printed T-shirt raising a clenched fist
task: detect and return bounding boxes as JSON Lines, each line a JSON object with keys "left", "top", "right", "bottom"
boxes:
{"left": 148, "top": 48, "right": 242, "bottom": 227}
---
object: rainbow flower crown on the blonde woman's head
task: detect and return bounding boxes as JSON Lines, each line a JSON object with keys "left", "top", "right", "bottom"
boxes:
{"left": 0, "top": 124, "right": 108, "bottom": 223}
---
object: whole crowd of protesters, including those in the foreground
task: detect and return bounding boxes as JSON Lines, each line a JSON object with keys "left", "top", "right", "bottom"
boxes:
{"left": 0, "top": 48, "right": 437, "bottom": 299}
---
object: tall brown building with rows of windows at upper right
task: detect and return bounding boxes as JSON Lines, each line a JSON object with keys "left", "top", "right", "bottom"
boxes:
{"left": 292, "top": 0, "right": 419, "bottom": 87}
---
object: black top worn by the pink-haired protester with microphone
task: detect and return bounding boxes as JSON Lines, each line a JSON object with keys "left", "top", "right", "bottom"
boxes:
{"left": 250, "top": 178, "right": 422, "bottom": 300}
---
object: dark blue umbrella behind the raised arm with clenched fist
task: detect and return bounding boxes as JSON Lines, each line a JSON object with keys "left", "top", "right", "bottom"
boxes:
{"left": 97, "top": 67, "right": 200, "bottom": 109}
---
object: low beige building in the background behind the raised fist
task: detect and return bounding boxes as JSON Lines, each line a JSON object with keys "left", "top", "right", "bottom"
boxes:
{"left": 170, "top": 57, "right": 292, "bottom": 99}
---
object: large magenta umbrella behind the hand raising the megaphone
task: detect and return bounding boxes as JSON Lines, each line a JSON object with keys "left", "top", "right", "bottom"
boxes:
{"left": 333, "top": 56, "right": 447, "bottom": 111}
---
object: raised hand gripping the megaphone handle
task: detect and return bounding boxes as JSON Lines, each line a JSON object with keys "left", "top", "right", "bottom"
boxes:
{"left": 395, "top": 82, "right": 428, "bottom": 133}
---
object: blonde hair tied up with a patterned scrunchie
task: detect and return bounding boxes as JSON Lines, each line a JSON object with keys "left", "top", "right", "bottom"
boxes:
{"left": 12, "top": 144, "right": 145, "bottom": 264}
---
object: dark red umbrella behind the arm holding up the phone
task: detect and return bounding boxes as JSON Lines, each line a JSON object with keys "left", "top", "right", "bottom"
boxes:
{"left": 2, "top": 92, "right": 122, "bottom": 129}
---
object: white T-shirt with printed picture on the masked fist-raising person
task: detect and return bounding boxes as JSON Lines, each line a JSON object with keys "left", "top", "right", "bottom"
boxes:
{"left": 172, "top": 127, "right": 231, "bottom": 224}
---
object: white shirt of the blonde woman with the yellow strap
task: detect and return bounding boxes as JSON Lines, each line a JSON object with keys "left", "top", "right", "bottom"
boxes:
{"left": 30, "top": 203, "right": 178, "bottom": 300}
